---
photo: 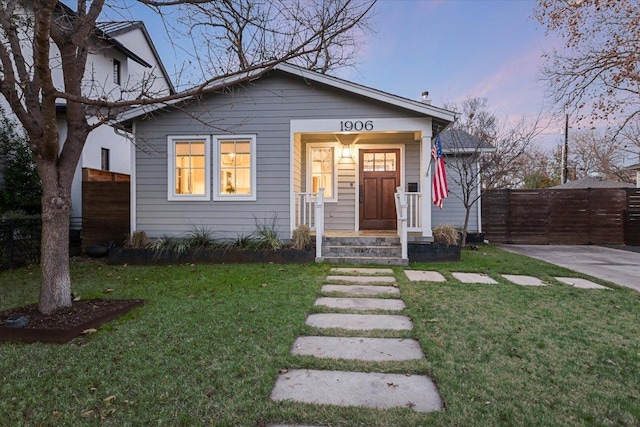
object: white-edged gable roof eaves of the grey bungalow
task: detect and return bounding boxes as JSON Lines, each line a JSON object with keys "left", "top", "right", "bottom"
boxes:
{"left": 118, "top": 63, "right": 455, "bottom": 130}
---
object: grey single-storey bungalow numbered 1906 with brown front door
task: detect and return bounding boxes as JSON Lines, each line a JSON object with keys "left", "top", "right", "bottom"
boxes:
{"left": 121, "top": 64, "right": 490, "bottom": 262}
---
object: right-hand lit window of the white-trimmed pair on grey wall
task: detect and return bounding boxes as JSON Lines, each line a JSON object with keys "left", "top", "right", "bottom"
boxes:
{"left": 213, "top": 135, "right": 256, "bottom": 201}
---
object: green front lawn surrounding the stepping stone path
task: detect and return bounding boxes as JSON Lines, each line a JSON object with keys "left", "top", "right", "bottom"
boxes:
{"left": 0, "top": 247, "right": 640, "bottom": 426}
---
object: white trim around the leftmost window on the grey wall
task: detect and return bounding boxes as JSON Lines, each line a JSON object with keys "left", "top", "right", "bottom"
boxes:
{"left": 167, "top": 135, "right": 211, "bottom": 201}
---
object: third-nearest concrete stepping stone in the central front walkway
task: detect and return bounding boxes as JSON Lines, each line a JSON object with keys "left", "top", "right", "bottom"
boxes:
{"left": 305, "top": 313, "right": 413, "bottom": 331}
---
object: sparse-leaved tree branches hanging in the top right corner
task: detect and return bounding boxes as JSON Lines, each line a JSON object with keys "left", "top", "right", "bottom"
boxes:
{"left": 535, "top": 0, "right": 640, "bottom": 137}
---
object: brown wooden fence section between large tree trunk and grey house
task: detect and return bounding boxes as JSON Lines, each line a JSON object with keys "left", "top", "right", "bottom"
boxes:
{"left": 82, "top": 168, "right": 131, "bottom": 249}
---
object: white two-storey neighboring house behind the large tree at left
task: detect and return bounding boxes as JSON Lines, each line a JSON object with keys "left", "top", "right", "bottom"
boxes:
{"left": 0, "top": 2, "right": 174, "bottom": 229}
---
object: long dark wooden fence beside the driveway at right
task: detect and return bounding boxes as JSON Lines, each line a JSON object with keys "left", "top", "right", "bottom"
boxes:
{"left": 482, "top": 188, "right": 640, "bottom": 245}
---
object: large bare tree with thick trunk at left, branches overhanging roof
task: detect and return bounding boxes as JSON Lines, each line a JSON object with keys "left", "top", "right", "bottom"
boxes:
{"left": 0, "top": 0, "right": 375, "bottom": 313}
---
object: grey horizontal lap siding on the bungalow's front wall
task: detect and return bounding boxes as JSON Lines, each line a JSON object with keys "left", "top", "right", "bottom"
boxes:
{"left": 134, "top": 75, "right": 428, "bottom": 239}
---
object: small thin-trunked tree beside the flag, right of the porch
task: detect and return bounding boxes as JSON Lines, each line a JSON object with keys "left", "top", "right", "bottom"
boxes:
{"left": 445, "top": 98, "right": 542, "bottom": 246}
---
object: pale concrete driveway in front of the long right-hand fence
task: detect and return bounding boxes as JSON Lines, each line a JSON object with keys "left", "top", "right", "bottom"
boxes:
{"left": 500, "top": 245, "right": 640, "bottom": 292}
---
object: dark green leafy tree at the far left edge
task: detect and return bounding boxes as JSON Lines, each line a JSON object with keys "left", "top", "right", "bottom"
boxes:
{"left": 0, "top": 108, "right": 42, "bottom": 215}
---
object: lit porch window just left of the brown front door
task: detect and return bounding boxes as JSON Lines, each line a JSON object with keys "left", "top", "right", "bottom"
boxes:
{"left": 307, "top": 144, "right": 337, "bottom": 202}
